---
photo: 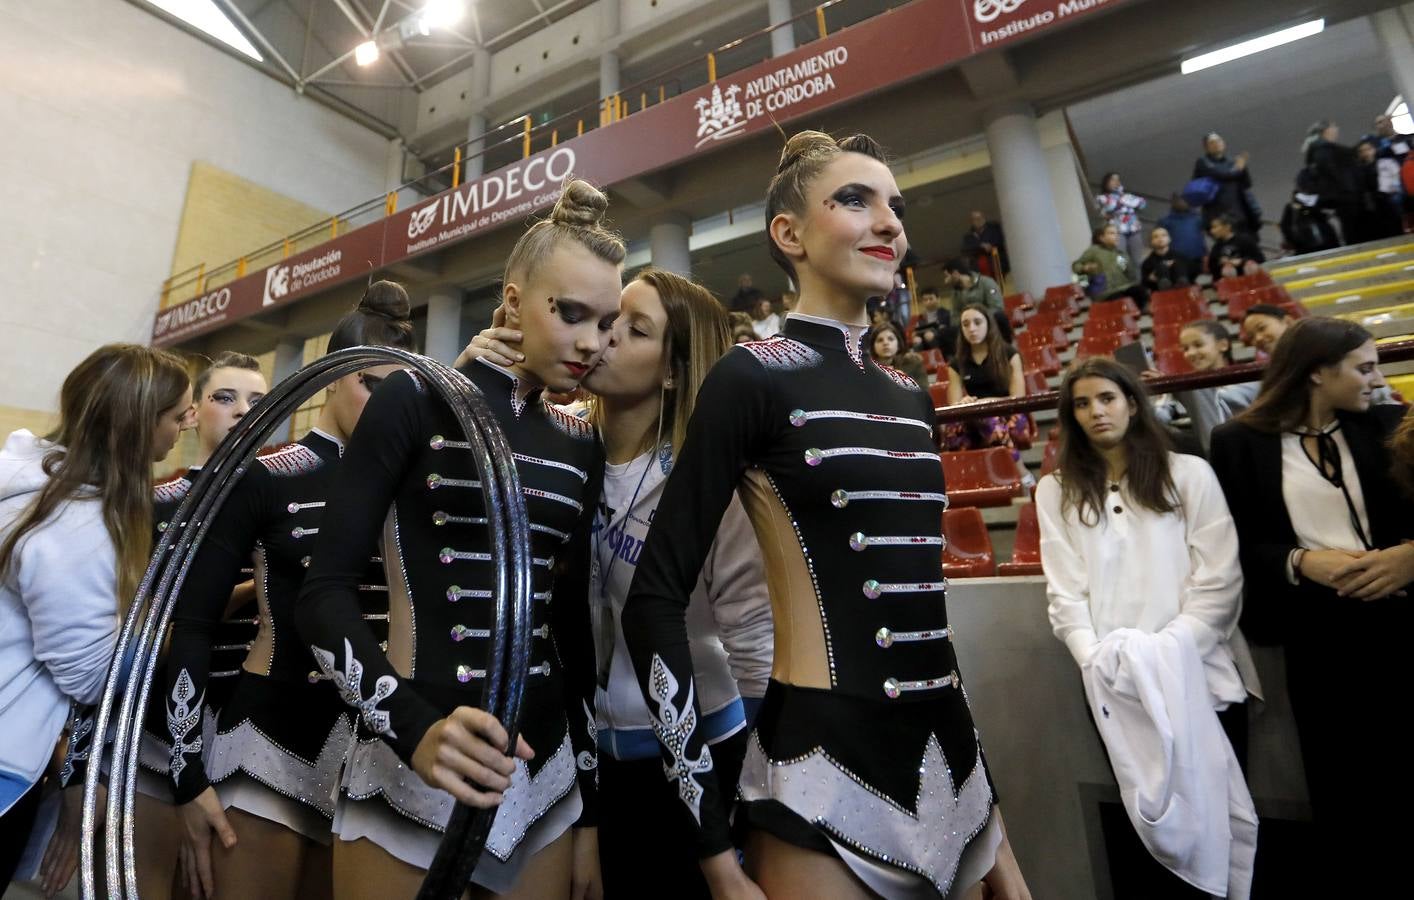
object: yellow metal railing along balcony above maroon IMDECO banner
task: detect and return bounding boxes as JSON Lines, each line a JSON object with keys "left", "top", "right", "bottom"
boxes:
{"left": 158, "top": 0, "right": 882, "bottom": 308}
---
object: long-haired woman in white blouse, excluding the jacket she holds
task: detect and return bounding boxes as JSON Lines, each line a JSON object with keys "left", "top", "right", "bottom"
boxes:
{"left": 1036, "top": 358, "right": 1257, "bottom": 761}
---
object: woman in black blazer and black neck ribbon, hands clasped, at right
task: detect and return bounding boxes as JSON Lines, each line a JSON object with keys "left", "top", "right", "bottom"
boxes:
{"left": 1212, "top": 317, "right": 1414, "bottom": 877}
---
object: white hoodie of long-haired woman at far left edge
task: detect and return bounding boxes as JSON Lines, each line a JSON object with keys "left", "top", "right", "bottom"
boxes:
{"left": 0, "top": 429, "right": 117, "bottom": 812}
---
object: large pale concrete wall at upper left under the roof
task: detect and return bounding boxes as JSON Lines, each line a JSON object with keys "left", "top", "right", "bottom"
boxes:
{"left": 0, "top": 0, "right": 387, "bottom": 423}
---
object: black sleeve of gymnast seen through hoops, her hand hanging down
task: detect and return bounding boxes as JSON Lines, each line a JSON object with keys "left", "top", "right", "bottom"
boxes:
{"left": 163, "top": 461, "right": 273, "bottom": 804}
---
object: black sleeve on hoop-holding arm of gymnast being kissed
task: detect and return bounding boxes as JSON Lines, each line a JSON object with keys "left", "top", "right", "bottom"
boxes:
{"left": 294, "top": 372, "right": 441, "bottom": 763}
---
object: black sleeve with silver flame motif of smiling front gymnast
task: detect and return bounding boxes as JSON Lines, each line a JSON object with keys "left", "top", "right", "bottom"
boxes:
{"left": 622, "top": 350, "right": 783, "bottom": 858}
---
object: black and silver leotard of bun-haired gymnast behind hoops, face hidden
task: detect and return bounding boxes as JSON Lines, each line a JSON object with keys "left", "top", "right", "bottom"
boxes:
{"left": 163, "top": 429, "right": 387, "bottom": 841}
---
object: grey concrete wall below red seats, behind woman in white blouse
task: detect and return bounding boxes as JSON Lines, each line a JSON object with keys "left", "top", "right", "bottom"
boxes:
{"left": 947, "top": 577, "right": 1309, "bottom": 900}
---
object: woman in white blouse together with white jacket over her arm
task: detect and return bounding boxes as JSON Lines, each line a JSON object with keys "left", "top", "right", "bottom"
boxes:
{"left": 1035, "top": 357, "right": 1261, "bottom": 897}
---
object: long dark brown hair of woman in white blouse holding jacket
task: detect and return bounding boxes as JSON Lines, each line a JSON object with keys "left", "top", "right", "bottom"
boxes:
{"left": 1056, "top": 357, "right": 1178, "bottom": 525}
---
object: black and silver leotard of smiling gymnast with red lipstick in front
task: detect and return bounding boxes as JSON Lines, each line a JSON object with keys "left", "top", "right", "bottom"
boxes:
{"left": 622, "top": 314, "right": 998, "bottom": 897}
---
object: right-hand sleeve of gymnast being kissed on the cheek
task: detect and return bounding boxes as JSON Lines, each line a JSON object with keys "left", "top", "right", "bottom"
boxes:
{"left": 550, "top": 460, "right": 604, "bottom": 828}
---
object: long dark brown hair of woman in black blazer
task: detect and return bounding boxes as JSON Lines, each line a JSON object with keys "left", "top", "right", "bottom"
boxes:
{"left": 1234, "top": 317, "right": 1374, "bottom": 434}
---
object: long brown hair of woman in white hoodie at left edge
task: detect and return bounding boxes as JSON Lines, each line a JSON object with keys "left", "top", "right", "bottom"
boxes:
{"left": 0, "top": 344, "right": 191, "bottom": 611}
